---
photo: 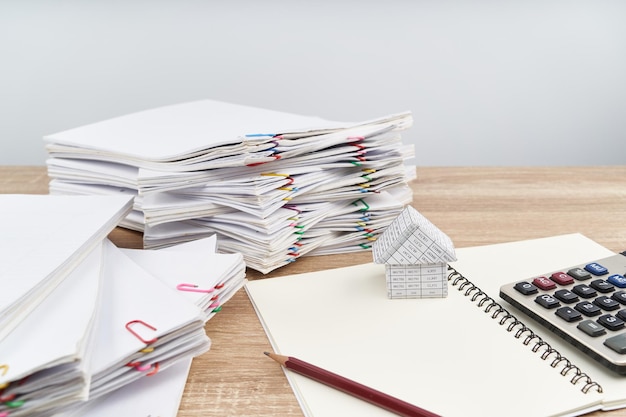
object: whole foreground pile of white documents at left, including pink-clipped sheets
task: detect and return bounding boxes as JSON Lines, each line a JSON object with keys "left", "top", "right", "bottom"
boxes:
{"left": 0, "top": 195, "right": 245, "bottom": 417}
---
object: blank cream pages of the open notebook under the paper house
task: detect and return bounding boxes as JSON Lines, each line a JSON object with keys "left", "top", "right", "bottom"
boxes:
{"left": 246, "top": 234, "right": 626, "bottom": 417}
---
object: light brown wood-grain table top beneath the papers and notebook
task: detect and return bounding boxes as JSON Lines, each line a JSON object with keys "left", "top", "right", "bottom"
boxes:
{"left": 0, "top": 166, "right": 626, "bottom": 417}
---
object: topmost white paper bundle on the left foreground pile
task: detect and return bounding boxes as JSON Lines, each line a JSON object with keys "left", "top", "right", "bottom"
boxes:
{"left": 0, "top": 194, "right": 131, "bottom": 340}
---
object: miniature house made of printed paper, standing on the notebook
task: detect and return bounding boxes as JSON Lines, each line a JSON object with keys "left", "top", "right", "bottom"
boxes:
{"left": 372, "top": 206, "right": 456, "bottom": 298}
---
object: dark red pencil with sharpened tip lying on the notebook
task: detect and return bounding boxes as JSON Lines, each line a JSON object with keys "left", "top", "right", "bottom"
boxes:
{"left": 264, "top": 352, "right": 440, "bottom": 417}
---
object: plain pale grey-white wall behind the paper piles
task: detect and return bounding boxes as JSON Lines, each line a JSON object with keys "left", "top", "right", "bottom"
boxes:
{"left": 0, "top": 0, "right": 626, "bottom": 166}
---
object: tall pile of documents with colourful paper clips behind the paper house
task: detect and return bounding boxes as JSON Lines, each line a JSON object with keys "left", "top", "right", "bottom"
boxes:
{"left": 44, "top": 100, "right": 415, "bottom": 273}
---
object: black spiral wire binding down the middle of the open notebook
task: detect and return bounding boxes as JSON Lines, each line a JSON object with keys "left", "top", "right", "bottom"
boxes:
{"left": 448, "top": 265, "right": 602, "bottom": 393}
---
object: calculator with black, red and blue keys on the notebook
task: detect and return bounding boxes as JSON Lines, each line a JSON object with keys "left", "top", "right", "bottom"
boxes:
{"left": 500, "top": 251, "right": 626, "bottom": 375}
